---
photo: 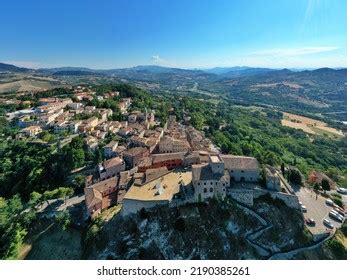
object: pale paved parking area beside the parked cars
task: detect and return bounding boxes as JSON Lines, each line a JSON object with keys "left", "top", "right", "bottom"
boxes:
{"left": 294, "top": 187, "right": 341, "bottom": 234}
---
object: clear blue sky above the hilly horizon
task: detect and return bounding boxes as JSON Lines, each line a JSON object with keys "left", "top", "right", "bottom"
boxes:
{"left": 0, "top": 0, "right": 347, "bottom": 68}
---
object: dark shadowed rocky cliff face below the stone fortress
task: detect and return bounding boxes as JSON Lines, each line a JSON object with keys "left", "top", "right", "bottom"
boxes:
{"left": 85, "top": 196, "right": 312, "bottom": 259}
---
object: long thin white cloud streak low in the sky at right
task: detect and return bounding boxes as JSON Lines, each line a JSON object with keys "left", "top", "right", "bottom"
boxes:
{"left": 251, "top": 46, "right": 339, "bottom": 57}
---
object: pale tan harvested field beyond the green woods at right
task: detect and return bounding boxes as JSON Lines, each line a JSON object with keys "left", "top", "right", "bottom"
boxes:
{"left": 282, "top": 112, "right": 344, "bottom": 137}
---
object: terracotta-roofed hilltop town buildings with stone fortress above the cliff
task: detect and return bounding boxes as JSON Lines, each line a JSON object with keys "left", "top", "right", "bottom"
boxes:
{"left": 7, "top": 86, "right": 300, "bottom": 219}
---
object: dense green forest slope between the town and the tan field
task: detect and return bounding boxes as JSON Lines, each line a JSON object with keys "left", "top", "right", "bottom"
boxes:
{"left": 168, "top": 97, "right": 347, "bottom": 183}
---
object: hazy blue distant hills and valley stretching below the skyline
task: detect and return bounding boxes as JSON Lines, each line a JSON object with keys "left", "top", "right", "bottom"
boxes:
{"left": 0, "top": 63, "right": 347, "bottom": 121}
